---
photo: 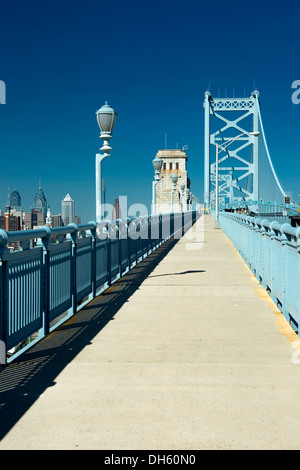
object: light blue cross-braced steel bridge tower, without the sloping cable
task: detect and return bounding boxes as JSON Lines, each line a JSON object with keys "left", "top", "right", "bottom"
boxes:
{"left": 203, "top": 90, "right": 259, "bottom": 210}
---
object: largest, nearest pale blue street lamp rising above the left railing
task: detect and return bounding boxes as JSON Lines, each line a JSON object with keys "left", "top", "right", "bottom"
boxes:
{"left": 96, "top": 101, "right": 117, "bottom": 223}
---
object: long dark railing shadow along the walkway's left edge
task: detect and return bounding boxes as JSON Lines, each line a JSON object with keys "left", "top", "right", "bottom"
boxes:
{"left": 0, "top": 239, "right": 178, "bottom": 440}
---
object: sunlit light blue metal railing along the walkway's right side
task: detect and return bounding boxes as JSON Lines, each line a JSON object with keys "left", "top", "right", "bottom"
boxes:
{"left": 220, "top": 212, "right": 300, "bottom": 334}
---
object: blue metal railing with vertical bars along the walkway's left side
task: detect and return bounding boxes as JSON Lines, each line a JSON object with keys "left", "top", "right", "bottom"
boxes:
{"left": 0, "top": 211, "right": 200, "bottom": 367}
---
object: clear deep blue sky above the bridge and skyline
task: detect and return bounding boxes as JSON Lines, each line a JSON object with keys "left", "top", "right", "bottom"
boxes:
{"left": 0, "top": 0, "right": 300, "bottom": 222}
